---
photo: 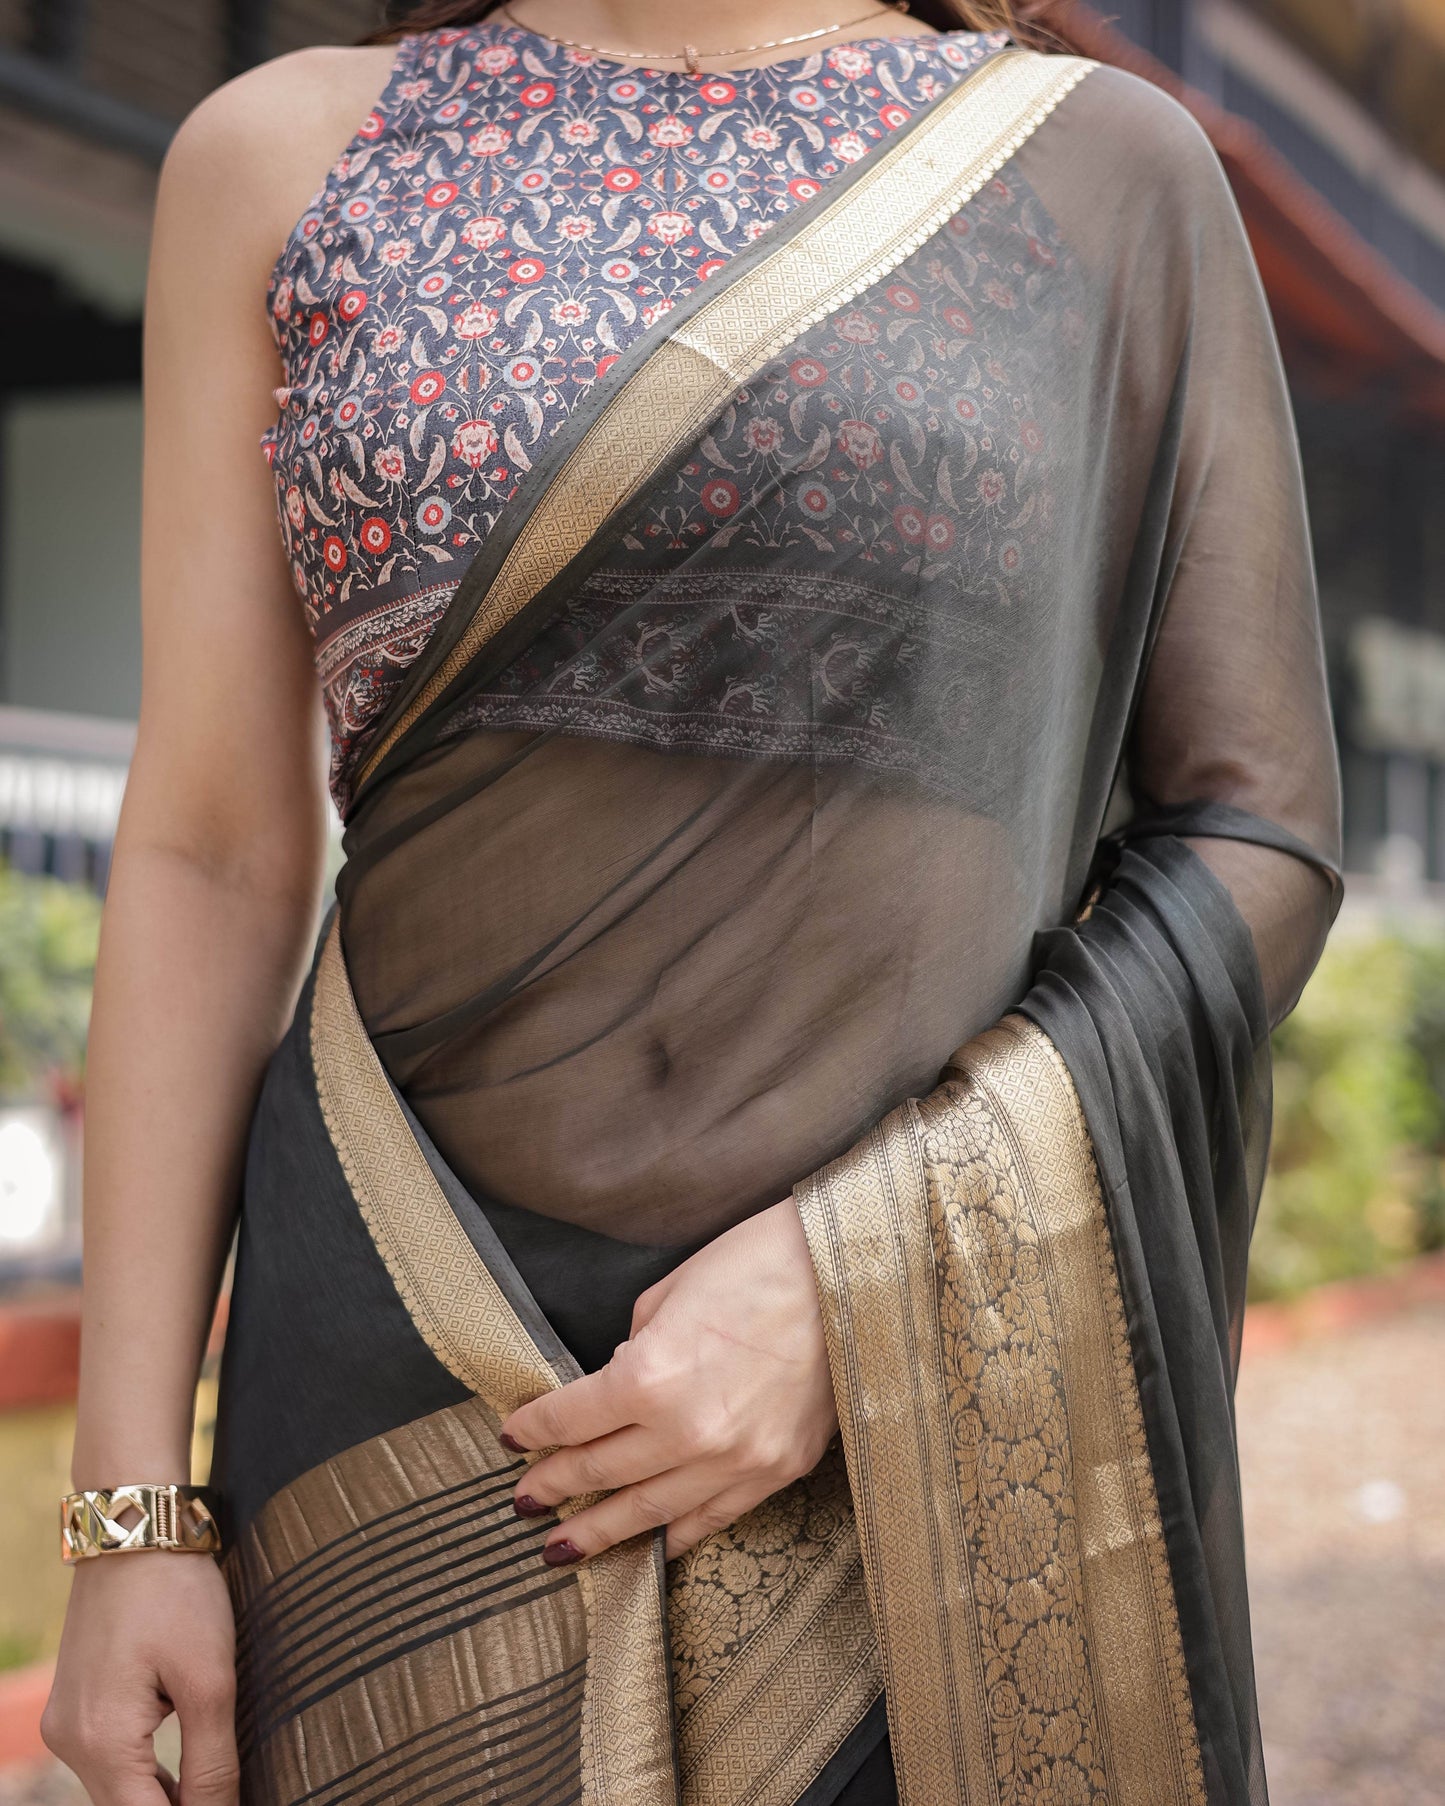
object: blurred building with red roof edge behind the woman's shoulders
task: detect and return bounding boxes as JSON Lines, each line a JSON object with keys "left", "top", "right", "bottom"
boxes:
{"left": 0, "top": 0, "right": 1445, "bottom": 896}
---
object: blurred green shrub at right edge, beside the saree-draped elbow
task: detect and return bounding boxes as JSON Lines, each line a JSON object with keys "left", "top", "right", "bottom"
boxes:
{"left": 1250, "top": 930, "right": 1445, "bottom": 1297}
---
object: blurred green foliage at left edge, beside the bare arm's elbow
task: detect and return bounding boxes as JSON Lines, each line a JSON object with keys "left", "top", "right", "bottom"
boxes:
{"left": 0, "top": 863, "right": 101, "bottom": 1096}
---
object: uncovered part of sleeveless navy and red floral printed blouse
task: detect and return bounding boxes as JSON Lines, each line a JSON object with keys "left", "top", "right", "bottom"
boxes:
{"left": 266, "top": 20, "right": 1002, "bottom": 807}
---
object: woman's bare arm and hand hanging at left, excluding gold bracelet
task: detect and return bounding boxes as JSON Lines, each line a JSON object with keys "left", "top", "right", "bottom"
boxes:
{"left": 45, "top": 51, "right": 388, "bottom": 1806}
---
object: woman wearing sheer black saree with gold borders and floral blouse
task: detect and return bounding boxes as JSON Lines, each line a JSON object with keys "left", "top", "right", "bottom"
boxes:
{"left": 47, "top": 0, "right": 1338, "bottom": 1806}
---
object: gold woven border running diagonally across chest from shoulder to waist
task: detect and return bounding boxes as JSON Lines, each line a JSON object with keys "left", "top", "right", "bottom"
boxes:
{"left": 358, "top": 51, "right": 1096, "bottom": 786}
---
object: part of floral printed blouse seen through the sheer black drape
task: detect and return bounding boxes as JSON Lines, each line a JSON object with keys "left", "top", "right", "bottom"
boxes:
{"left": 450, "top": 172, "right": 1080, "bottom": 809}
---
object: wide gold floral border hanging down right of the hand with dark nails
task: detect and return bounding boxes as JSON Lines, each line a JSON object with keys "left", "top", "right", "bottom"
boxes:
{"left": 797, "top": 1017, "right": 1205, "bottom": 1806}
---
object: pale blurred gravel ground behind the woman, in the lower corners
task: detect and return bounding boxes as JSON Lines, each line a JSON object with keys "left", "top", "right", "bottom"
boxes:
{"left": 0, "top": 1306, "right": 1445, "bottom": 1806}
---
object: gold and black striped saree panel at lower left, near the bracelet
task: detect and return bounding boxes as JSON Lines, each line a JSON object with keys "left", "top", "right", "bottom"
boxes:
{"left": 229, "top": 1401, "right": 587, "bottom": 1806}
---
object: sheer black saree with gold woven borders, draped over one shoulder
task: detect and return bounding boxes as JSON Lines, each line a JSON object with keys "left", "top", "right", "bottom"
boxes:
{"left": 217, "top": 49, "right": 1338, "bottom": 1806}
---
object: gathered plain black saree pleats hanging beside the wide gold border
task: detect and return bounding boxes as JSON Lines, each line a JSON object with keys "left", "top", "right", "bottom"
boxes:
{"left": 1022, "top": 840, "right": 1270, "bottom": 1801}
